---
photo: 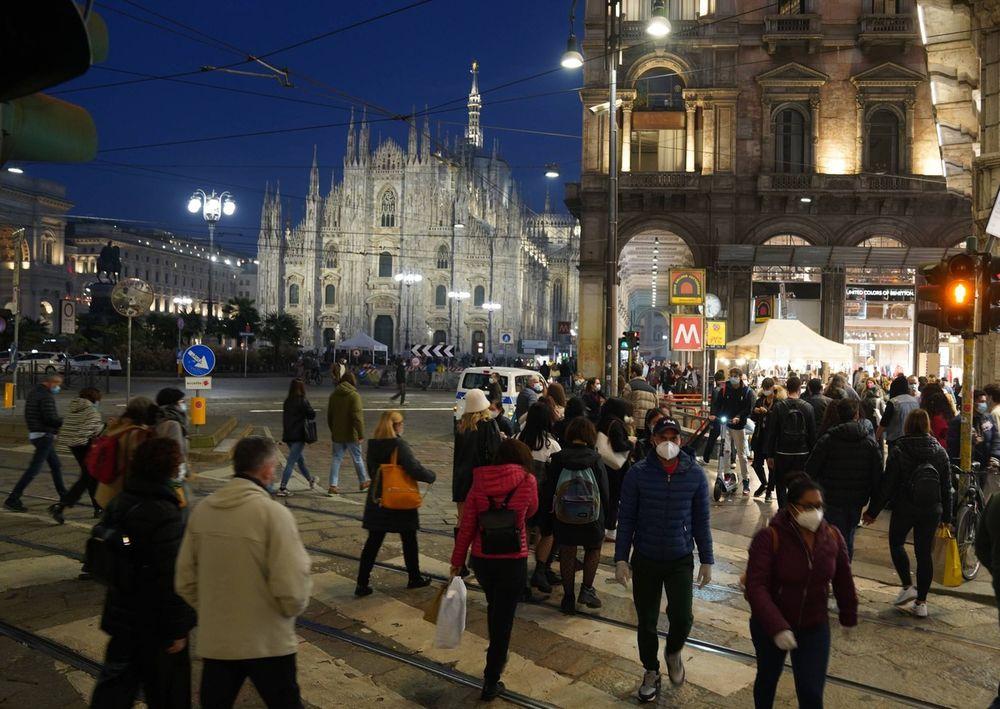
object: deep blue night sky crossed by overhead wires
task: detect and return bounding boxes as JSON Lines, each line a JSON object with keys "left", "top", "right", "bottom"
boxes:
{"left": 31, "top": 0, "right": 582, "bottom": 253}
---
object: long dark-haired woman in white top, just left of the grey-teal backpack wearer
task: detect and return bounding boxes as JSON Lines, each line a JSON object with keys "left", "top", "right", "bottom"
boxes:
{"left": 517, "top": 401, "right": 561, "bottom": 593}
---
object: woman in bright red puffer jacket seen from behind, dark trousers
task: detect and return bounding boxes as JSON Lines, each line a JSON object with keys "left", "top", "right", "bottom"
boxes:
{"left": 451, "top": 438, "right": 538, "bottom": 701}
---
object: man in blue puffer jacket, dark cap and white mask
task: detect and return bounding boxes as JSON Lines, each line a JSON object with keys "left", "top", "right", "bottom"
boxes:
{"left": 615, "top": 418, "right": 714, "bottom": 702}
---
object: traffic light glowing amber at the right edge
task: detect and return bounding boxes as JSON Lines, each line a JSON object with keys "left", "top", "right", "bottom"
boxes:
{"left": 917, "top": 253, "right": 979, "bottom": 335}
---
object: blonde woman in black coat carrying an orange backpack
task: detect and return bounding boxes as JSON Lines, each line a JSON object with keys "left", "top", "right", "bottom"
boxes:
{"left": 354, "top": 411, "right": 437, "bottom": 596}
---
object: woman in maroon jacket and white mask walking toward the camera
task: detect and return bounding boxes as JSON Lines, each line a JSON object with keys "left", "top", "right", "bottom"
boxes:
{"left": 746, "top": 474, "right": 858, "bottom": 709}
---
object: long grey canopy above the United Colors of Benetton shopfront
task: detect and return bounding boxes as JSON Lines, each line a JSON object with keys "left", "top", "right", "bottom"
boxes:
{"left": 716, "top": 244, "right": 961, "bottom": 271}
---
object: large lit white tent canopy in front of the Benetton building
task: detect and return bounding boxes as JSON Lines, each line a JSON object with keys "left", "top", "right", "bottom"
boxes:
{"left": 717, "top": 318, "right": 854, "bottom": 366}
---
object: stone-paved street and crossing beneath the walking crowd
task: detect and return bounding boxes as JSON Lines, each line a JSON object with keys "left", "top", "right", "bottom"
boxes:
{"left": 0, "top": 380, "right": 1000, "bottom": 708}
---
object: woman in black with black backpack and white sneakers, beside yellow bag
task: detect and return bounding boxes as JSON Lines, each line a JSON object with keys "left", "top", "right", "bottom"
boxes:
{"left": 864, "top": 409, "right": 952, "bottom": 618}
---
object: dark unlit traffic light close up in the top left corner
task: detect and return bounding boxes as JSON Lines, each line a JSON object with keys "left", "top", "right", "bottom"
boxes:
{"left": 0, "top": 0, "right": 108, "bottom": 164}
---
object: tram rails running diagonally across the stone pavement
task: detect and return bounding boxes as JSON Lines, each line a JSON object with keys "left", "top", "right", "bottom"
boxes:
{"left": 0, "top": 535, "right": 960, "bottom": 709}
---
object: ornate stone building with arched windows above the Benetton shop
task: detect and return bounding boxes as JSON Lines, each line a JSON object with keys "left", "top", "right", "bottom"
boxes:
{"left": 566, "top": 0, "right": 976, "bottom": 374}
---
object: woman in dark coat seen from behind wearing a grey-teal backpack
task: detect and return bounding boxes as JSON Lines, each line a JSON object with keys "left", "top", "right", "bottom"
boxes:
{"left": 541, "top": 418, "right": 608, "bottom": 613}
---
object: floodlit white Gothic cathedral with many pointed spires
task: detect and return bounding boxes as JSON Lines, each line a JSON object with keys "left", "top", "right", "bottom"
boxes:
{"left": 257, "top": 64, "right": 579, "bottom": 354}
